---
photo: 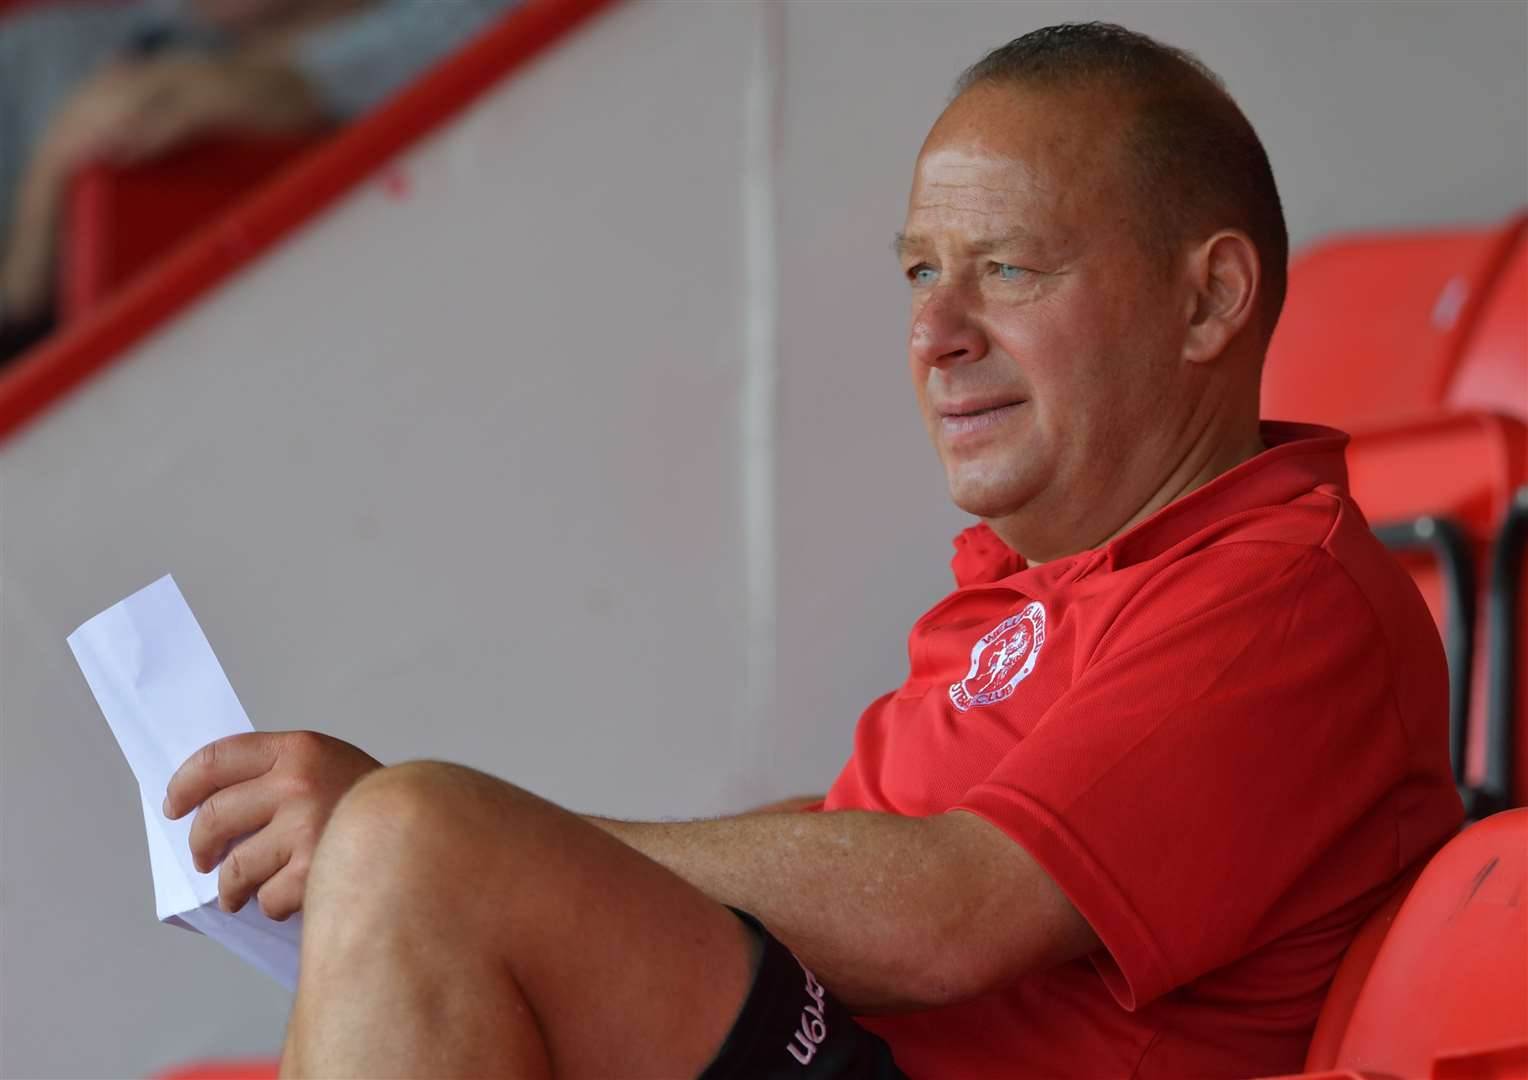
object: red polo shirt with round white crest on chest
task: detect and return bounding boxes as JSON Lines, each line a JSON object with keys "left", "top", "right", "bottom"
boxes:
{"left": 825, "top": 423, "right": 1462, "bottom": 1080}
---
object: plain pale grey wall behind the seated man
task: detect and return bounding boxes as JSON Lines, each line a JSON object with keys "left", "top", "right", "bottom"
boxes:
{"left": 0, "top": 0, "right": 1528, "bottom": 1077}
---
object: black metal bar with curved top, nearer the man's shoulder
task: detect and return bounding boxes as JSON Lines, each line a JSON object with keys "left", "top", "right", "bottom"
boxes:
{"left": 1374, "top": 515, "right": 1484, "bottom": 817}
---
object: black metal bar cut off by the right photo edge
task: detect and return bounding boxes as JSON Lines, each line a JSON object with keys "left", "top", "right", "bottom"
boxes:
{"left": 1484, "top": 487, "right": 1528, "bottom": 810}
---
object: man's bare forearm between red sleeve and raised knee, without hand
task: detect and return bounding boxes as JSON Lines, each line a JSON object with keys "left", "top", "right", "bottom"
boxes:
{"left": 590, "top": 811, "right": 1100, "bottom": 1013}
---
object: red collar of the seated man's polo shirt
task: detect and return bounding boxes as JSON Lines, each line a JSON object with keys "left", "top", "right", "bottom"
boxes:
{"left": 950, "top": 420, "right": 1348, "bottom": 588}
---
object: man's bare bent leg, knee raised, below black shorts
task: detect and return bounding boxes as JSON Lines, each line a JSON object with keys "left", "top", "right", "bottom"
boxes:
{"left": 281, "top": 762, "right": 758, "bottom": 1080}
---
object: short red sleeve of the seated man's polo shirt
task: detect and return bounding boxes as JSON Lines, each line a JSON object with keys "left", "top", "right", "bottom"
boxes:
{"left": 960, "top": 542, "right": 1417, "bottom": 1008}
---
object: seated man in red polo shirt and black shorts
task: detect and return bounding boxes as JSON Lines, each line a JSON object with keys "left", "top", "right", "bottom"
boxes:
{"left": 167, "top": 24, "right": 1461, "bottom": 1080}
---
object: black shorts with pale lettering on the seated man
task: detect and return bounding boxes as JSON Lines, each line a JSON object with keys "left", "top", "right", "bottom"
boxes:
{"left": 700, "top": 907, "right": 908, "bottom": 1080}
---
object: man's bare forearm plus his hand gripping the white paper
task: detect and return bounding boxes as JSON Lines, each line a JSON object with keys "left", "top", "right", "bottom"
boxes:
{"left": 165, "top": 732, "right": 1100, "bottom": 1013}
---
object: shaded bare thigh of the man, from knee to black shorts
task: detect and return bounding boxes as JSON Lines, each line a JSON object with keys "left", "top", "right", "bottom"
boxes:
{"left": 337, "top": 762, "right": 761, "bottom": 1077}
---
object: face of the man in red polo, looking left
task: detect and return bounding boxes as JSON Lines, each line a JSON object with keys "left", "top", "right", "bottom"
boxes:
{"left": 898, "top": 87, "right": 1184, "bottom": 558}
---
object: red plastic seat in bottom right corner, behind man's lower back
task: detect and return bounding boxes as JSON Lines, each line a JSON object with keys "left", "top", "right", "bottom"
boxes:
{"left": 1259, "top": 810, "right": 1528, "bottom": 1080}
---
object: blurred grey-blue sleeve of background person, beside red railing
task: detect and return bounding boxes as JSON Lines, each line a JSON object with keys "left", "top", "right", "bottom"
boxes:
{"left": 292, "top": 0, "right": 516, "bottom": 121}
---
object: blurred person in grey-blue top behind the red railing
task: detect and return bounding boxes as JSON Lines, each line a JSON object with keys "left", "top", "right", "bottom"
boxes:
{"left": 0, "top": 0, "right": 515, "bottom": 361}
